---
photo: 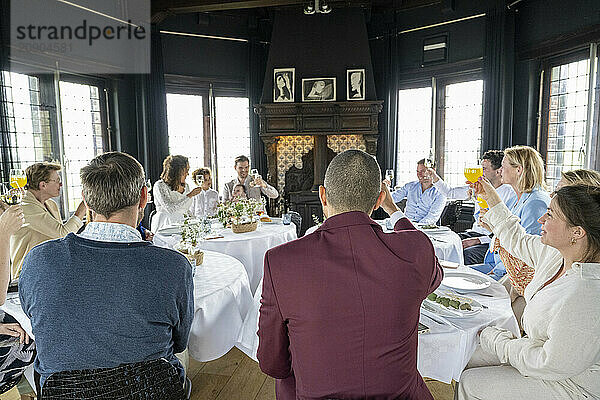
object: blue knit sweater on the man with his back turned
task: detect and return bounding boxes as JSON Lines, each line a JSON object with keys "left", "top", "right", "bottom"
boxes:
{"left": 19, "top": 233, "right": 194, "bottom": 385}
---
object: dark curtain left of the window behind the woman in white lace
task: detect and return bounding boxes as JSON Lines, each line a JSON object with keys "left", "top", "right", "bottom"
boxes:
{"left": 137, "top": 24, "right": 169, "bottom": 182}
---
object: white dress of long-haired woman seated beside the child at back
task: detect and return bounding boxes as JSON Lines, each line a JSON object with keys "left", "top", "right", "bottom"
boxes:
{"left": 150, "top": 179, "right": 192, "bottom": 233}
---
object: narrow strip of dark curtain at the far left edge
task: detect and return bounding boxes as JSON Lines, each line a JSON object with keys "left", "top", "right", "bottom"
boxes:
{"left": 0, "top": 0, "right": 12, "bottom": 182}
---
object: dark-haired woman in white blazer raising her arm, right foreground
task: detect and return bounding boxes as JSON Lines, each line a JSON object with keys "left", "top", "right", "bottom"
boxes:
{"left": 456, "top": 178, "right": 600, "bottom": 400}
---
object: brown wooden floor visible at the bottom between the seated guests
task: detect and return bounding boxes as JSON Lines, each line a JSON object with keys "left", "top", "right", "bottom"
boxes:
{"left": 0, "top": 347, "right": 453, "bottom": 400}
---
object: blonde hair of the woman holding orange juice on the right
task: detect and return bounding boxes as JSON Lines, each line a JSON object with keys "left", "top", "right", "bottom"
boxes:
{"left": 504, "top": 146, "right": 546, "bottom": 193}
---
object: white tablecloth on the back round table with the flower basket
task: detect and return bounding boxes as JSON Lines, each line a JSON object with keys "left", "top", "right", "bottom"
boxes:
{"left": 154, "top": 218, "right": 297, "bottom": 293}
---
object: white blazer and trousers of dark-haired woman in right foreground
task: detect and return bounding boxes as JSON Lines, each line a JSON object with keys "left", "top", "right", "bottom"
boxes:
{"left": 458, "top": 203, "right": 600, "bottom": 400}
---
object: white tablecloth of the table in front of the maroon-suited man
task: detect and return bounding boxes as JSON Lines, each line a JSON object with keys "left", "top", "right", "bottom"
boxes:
{"left": 236, "top": 266, "right": 519, "bottom": 383}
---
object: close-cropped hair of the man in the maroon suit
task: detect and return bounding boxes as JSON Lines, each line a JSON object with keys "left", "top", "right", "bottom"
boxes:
{"left": 324, "top": 150, "right": 381, "bottom": 214}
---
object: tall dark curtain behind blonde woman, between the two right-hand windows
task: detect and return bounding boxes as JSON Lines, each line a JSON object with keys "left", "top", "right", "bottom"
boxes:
{"left": 481, "top": 2, "right": 515, "bottom": 151}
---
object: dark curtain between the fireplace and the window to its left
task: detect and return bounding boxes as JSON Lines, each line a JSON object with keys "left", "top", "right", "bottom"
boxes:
{"left": 246, "top": 38, "right": 268, "bottom": 178}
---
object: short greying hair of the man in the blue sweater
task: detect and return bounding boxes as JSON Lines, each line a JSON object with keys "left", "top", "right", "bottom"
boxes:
{"left": 80, "top": 151, "right": 145, "bottom": 218}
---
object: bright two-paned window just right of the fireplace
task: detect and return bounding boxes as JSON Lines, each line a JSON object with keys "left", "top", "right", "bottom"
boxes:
{"left": 396, "top": 79, "right": 483, "bottom": 186}
